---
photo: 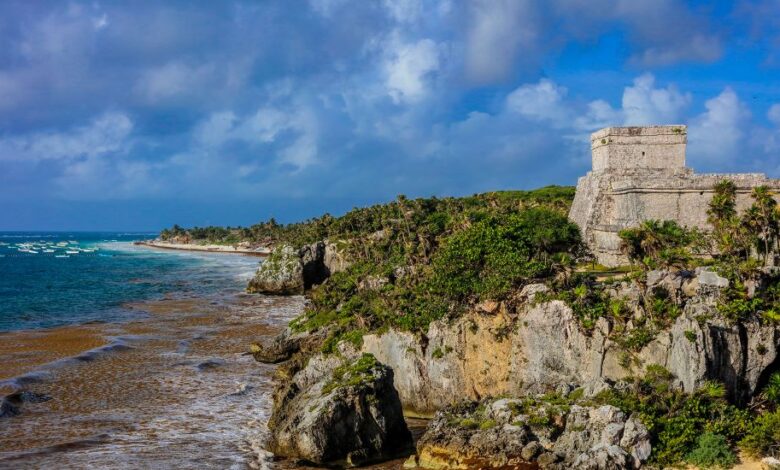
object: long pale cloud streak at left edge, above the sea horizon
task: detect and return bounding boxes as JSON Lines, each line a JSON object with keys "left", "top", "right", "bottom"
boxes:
{"left": 0, "top": 113, "right": 133, "bottom": 162}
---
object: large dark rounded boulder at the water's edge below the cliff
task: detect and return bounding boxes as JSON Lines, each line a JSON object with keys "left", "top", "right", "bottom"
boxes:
{"left": 268, "top": 353, "right": 412, "bottom": 466}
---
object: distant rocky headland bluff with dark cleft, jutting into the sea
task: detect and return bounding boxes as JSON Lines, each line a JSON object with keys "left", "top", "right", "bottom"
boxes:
{"left": 247, "top": 241, "right": 349, "bottom": 295}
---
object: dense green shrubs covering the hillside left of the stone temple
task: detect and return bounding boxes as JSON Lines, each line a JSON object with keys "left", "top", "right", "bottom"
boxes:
{"left": 284, "top": 188, "right": 582, "bottom": 351}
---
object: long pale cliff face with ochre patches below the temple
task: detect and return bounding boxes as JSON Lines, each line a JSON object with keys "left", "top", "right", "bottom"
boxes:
{"left": 361, "top": 270, "right": 780, "bottom": 415}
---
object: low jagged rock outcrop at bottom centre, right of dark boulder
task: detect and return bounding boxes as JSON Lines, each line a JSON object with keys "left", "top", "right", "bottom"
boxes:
{"left": 407, "top": 399, "right": 651, "bottom": 469}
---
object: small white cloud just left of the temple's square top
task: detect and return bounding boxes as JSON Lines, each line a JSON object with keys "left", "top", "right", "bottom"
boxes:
{"left": 506, "top": 78, "right": 569, "bottom": 127}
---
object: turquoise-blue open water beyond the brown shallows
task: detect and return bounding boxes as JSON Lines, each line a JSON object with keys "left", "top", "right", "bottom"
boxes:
{"left": 0, "top": 232, "right": 258, "bottom": 331}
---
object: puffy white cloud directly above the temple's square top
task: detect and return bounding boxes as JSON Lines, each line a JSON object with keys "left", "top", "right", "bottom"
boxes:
{"left": 622, "top": 74, "right": 691, "bottom": 125}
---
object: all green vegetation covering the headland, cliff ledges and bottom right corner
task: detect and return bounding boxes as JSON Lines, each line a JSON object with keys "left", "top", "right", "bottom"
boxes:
{"left": 161, "top": 181, "right": 780, "bottom": 467}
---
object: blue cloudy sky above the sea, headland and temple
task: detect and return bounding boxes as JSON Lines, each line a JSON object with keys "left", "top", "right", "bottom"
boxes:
{"left": 0, "top": 0, "right": 780, "bottom": 230}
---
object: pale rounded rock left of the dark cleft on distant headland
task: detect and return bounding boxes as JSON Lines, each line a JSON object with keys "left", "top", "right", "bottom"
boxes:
{"left": 247, "top": 245, "right": 304, "bottom": 295}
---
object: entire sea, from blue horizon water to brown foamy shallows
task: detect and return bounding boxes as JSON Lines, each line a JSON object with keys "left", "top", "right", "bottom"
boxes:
{"left": 0, "top": 232, "right": 304, "bottom": 469}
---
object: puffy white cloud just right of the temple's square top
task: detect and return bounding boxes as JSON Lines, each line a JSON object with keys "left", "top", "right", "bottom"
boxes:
{"left": 688, "top": 88, "right": 750, "bottom": 165}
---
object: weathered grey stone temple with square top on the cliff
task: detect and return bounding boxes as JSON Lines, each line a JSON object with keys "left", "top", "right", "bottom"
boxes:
{"left": 569, "top": 125, "right": 780, "bottom": 266}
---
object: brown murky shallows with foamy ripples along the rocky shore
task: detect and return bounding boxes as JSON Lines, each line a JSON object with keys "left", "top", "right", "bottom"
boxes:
{"left": 0, "top": 295, "right": 303, "bottom": 468}
